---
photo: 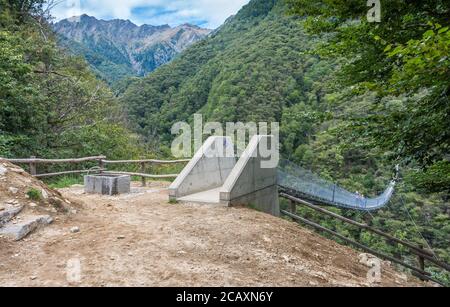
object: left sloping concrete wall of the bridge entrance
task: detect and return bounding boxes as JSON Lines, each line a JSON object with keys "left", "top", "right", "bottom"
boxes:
{"left": 169, "top": 136, "right": 236, "bottom": 201}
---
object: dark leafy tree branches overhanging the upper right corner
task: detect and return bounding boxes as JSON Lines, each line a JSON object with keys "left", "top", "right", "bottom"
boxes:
{"left": 288, "top": 0, "right": 450, "bottom": 192}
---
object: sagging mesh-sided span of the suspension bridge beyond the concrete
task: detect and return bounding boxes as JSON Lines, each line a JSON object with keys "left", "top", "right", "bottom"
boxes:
{"left": 278, "top": 160, "right": 395, "bottom": 211}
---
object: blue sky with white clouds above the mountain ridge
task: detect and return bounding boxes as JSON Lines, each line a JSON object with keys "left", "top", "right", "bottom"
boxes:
{"left": 52, "top": 0, "right": 250, "bottom": 29}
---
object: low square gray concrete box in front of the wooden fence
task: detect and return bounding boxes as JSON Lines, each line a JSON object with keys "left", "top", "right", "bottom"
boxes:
{"left": 84, "top": 174, "right": 131, "bottom": 195}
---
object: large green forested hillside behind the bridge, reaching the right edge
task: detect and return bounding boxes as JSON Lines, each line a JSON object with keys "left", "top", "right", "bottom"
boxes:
{"left": 121, "top": 0, "right": 450, "bottom": 280}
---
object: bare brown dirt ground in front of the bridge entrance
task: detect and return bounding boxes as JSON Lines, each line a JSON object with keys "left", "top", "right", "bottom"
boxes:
{"left": 0, "top": 183, "right": 428, "bottom": 286}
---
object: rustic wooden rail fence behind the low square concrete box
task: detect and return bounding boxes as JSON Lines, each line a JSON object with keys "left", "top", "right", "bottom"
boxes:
{"left": 6, "top": 156, "right": 190, "bottom": 186}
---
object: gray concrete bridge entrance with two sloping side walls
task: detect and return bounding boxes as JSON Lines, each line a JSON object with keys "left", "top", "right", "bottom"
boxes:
{"left": 169, "top": 135, "right": 280, "bottom": 216}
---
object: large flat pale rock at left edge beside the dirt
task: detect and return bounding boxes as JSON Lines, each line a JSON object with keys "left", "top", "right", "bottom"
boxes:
{"left": 0, "top": 215, "right": 53, "bottom": 241}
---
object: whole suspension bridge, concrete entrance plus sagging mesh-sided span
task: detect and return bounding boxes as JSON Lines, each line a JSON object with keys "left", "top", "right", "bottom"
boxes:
{"left": 170, "top": 136, "right": 397, "bottom": 215}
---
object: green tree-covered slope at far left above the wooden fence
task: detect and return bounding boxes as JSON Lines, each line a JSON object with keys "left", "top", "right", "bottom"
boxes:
{"left": 0, "top": 0, "right": 139, "bottom": 158}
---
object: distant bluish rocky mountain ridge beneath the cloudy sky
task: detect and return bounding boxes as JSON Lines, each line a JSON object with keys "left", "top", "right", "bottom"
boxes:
{"left": 53, "top": 15, "right": 210, "bottom": 82}
